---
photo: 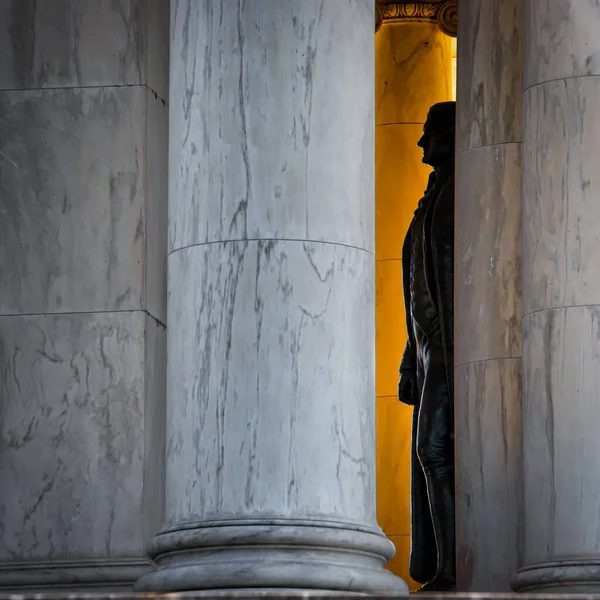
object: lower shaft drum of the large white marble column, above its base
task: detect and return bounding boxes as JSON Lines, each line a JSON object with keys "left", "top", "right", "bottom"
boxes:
{"left": 166, "top": 240, "right": 376, "bottom": 526}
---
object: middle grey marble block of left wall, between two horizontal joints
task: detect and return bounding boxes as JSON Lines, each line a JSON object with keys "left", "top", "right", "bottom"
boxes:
{"left": 0, "top": 87, "right": 146, "bottom": 314}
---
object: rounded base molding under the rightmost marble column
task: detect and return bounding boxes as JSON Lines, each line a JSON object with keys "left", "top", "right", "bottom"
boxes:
{"left": 512, "top": 557, "right": 600, "bottom": 594}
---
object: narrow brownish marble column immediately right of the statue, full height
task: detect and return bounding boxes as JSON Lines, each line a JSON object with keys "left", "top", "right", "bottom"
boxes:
{"left": 454, "top": 0, "right": 523, "bottom": 592}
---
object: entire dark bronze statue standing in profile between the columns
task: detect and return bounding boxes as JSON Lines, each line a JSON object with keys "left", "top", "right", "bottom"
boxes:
{"left": 398, "top": 102, "right": 456, "bottom": 591}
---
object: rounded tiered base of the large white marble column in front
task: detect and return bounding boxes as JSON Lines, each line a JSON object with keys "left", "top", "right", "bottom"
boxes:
{"left": 134, "top": 520, "right": 408, "bottom": 594}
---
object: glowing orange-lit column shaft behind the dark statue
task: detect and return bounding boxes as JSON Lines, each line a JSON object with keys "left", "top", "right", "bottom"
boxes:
{"left": 375, "top": 10, "right": 452, "bottom": 589}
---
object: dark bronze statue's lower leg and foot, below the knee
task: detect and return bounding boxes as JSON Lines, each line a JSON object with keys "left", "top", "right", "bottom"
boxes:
{"left": 419, "top": 466, "right": 456, "bottom": 592}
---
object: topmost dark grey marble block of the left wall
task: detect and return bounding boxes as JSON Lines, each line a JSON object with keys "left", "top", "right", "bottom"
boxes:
{"left": 0, "top": 0, "right": 169, "bottom": 100}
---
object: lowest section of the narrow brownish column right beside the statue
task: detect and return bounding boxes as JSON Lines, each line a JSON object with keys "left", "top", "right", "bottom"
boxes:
{"left": 454, "top": 358, "right": 522, "bottom": 592}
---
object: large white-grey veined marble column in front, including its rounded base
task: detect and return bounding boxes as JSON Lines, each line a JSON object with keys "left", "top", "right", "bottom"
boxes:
{"left": 137, "top": 0, "right": 406, "bottom": 592}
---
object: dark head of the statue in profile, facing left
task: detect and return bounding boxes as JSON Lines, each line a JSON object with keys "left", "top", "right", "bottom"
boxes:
{"left": 417, "top": 102, "right": 456, "bottom": 167}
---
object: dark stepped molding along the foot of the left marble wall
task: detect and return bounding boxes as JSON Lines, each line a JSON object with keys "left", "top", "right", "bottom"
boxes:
{"left": 0, "top": 558, "right": 154, "bottom": 594}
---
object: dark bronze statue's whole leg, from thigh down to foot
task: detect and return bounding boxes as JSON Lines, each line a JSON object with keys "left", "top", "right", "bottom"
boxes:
{"left": 417, "top": 336, "right": 456, "bottom": 591}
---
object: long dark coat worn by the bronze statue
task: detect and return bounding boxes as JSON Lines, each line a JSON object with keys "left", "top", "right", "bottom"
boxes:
{"left": 400, "top": 168, "right": 454, "bottom": 583}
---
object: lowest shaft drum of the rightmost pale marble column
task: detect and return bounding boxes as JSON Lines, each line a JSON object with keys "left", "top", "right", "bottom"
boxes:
{"left": 523, "top": 306, "right": 600, "bottom": 564}
